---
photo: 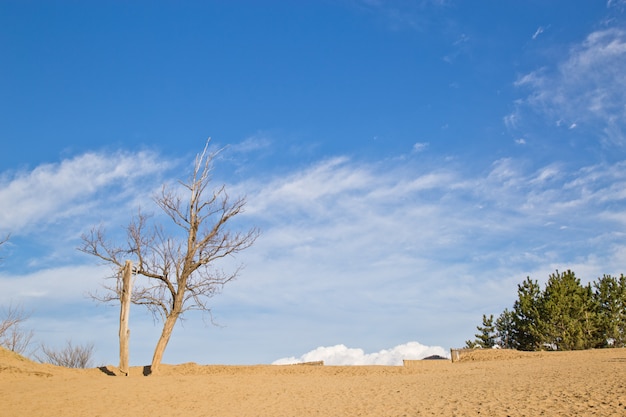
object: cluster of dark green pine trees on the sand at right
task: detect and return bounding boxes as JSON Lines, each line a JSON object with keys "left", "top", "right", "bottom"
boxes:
{"left": 465, "top": 270, "right": 626, "bottom": 351}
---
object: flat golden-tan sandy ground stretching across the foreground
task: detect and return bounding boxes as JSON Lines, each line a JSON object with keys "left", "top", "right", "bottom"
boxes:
{"left": 0, "top": 349, "right": 626, "bottom": 417}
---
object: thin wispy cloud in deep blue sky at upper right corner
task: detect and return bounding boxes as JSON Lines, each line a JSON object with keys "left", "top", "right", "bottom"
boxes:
{"left": 505, "top": 28, "right": 626, "bottom": 146}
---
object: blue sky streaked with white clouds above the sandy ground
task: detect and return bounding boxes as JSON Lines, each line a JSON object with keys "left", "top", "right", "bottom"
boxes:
{"left": 0, "top": 0, "right": 626, "bottom": 365}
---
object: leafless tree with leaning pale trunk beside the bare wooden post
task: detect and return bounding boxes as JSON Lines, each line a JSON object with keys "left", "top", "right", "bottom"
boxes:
{"left": 79, "top": 142, "right": 259, "bottom": 374}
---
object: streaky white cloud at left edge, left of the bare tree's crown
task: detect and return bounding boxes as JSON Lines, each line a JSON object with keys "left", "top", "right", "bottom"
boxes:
{"left": 0, "top": 152, "right": 169, "bottom": 235}
